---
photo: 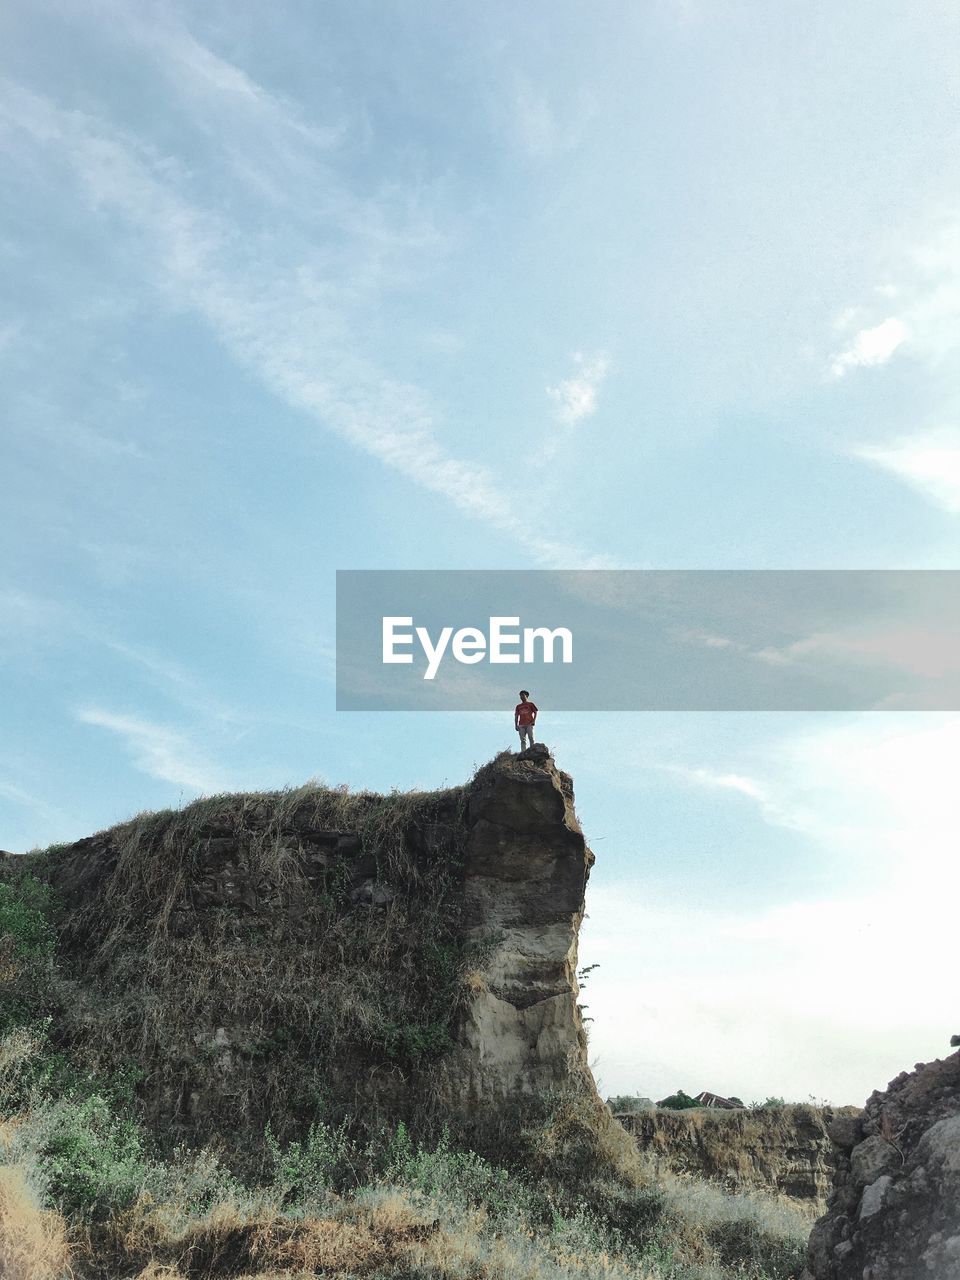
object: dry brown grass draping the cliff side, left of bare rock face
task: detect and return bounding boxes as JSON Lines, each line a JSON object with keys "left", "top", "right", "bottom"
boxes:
{"left": 28, "top": 785, "right": 477, "bottom": 1157}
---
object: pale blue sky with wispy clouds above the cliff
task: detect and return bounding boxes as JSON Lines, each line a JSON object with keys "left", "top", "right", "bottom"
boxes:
{"left": 0, "top": 0, "right": 960, "bottom": 1103}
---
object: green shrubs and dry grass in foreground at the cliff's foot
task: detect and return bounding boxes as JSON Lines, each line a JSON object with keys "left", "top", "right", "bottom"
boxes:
{"left": 0, "top": 1032, "right": 810, "bottom": 1280}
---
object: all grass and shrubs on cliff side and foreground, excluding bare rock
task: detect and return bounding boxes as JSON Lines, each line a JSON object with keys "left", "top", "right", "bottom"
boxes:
{"left": 0, "top": 762, "right": 809, "bottom": 1280}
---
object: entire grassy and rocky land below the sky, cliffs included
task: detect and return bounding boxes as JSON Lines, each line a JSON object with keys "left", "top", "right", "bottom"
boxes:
{"left": 0, "top": 746, "right": 960, "bottom": 1280}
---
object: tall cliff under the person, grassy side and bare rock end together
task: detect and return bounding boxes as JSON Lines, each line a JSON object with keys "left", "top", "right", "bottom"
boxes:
{"left": 17, "top": 746, "right": 599, "bottom": 1140}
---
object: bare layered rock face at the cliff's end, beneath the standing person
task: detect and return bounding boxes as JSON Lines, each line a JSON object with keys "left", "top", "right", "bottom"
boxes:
{"left": 449, "top": 744, "right": 594, "bottom": 1100}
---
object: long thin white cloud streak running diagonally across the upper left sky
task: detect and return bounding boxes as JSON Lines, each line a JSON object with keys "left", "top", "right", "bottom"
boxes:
{"left": 0, "top": 73, "right": 608, "bottom": 568}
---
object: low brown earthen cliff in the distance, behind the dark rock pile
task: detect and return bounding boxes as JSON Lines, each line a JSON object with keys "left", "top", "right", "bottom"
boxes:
{"left": 617, "top": 1103, "right": 859, "bottom": 1208}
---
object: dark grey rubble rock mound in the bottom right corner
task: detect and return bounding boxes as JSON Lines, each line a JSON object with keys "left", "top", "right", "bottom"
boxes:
{"left": 806, "top": 1053, "right": 960, "bottom": 1280}
